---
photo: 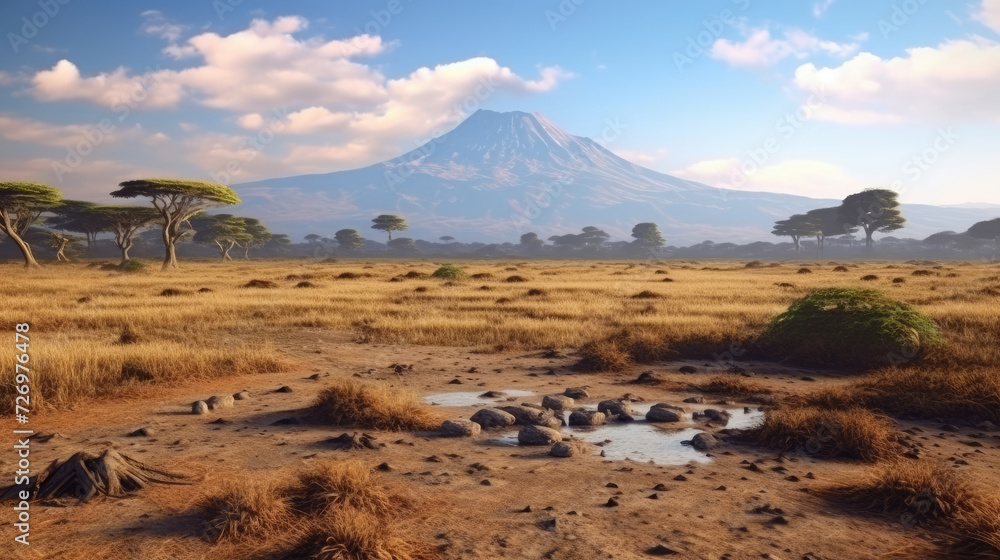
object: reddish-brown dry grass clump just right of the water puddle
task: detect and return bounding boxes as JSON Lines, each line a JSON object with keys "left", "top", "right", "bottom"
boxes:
{"left": 751, "top": 405, "right": 899, "bottom": 462}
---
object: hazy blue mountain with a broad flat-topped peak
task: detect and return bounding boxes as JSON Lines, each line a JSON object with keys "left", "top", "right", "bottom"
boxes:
{"left": 233, "top": 110, "right": 996, "bottom": 245}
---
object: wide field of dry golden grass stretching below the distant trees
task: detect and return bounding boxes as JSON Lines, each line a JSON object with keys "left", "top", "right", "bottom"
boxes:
{"left": 0, "top": 260, "right": 1000, "bottom": 412}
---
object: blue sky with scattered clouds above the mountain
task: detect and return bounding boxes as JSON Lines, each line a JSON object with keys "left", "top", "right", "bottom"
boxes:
{"left": 0, "top": 0, "right": 1000, "bottom": 204}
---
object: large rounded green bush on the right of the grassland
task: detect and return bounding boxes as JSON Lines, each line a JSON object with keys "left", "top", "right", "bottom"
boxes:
{"left": 765, "top": 288, "right": 943, "bottom": 368}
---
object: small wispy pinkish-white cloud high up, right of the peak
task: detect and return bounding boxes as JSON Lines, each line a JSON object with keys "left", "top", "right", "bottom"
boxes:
{"left": 709, "top": 28, "right": 868, "bottom": 67}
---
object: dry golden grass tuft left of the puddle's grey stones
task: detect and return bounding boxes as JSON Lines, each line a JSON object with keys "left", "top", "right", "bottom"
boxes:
{"left": 313, "top": 379, "right": 441, "bottom": 430}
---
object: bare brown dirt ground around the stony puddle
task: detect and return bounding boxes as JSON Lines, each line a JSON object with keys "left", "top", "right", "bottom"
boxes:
{"left": 0, "top": 329, "right": 1000, "bottom": 560}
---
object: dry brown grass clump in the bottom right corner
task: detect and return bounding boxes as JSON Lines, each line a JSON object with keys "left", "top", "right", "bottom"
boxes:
{"left": 822, "top": 461, "right": 1000, "bottom": 559}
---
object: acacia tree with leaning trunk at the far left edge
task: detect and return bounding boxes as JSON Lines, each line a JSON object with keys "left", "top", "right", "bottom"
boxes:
{"left": 0, "top": 181, "right": 62, "bottom": 268}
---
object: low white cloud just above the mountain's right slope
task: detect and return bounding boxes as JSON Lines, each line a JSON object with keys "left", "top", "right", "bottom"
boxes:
{"left": 670, "top": 158, "right": 859, "bottom": 198}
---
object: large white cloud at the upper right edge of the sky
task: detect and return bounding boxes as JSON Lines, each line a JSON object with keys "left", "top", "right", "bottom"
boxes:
{"left": 794, "top": 37, "right": 1000, "bottom": 124}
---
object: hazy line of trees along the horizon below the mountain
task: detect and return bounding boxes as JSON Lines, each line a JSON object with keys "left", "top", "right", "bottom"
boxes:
{"left": 0, "top": 179, "right": 1000, "bottom": 270}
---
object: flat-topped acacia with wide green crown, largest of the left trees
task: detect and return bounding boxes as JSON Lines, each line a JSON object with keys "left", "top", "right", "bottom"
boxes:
{"left": 111, "top": 179, "right": 240, "bottom": 270}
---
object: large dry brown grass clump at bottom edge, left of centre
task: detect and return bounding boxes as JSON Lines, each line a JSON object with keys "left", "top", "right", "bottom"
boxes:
{"left": 197, "top": 460, "right": 437, "bottom": 560}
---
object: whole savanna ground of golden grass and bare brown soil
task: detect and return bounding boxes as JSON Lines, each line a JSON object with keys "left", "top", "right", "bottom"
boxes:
{"left": 0, "top": 259, "right": 1000, "bottom": 560}
